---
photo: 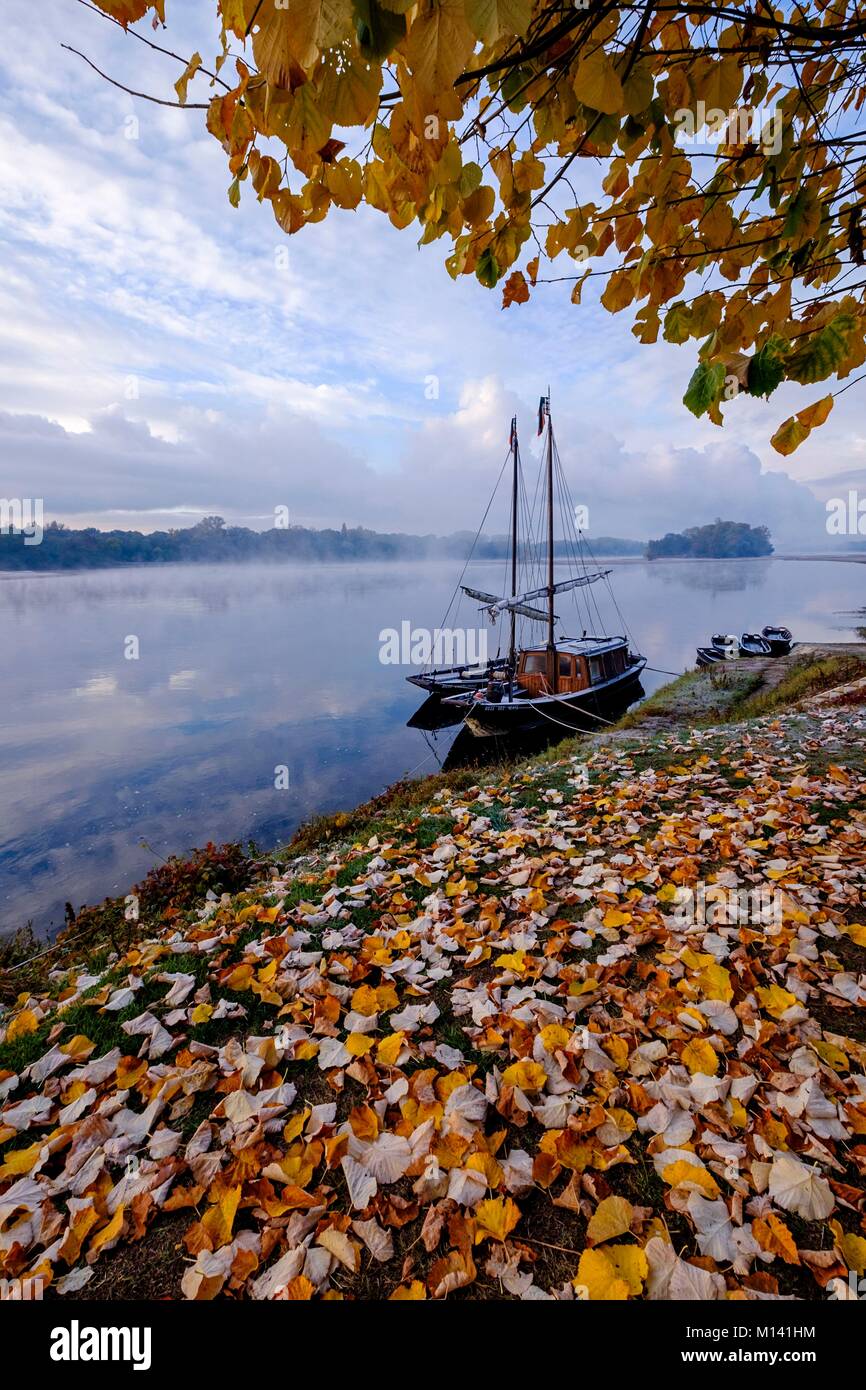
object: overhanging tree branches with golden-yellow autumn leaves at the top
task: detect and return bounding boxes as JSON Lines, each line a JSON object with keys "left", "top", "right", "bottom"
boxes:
{"left": 88, "top": 0, "right": 866, "bottom": 453}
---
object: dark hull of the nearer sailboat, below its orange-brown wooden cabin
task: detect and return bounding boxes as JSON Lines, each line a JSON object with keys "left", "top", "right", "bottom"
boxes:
{"left": 446, "top": 657, "right": 646, "bottom": 738}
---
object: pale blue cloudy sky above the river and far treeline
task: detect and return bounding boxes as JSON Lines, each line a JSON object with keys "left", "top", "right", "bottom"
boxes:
{"left": 0, "top": 0, "right": 866, "bottom": 550}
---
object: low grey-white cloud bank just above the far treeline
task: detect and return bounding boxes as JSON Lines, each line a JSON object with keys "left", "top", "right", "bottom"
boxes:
{"left": 0, "top": 377, "right": 826, "bottom": 548}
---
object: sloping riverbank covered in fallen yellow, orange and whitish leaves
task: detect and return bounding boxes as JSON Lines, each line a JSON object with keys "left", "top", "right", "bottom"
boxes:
{"left": 0, "top": 681, "right": 866, "bottom": 1300}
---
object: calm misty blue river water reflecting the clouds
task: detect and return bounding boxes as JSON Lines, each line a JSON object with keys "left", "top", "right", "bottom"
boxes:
{"left": 0, "top": 559, "right": 866, "bottom": 931}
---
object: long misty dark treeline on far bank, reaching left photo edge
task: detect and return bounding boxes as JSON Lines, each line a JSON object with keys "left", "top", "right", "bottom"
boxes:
{"left": 0, "top": 517, "right": 644, "bottom": 570}
